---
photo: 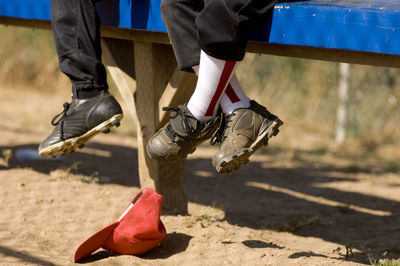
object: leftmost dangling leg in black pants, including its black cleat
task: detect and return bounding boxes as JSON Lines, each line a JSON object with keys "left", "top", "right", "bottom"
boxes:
{"left": 39, "top": 0, "right": 122, "bottom": 157}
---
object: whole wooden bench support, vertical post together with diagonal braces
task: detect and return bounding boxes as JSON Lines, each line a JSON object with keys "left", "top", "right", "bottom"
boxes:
{"left": 102, "top": 38, "right": 196, "bottom": 214}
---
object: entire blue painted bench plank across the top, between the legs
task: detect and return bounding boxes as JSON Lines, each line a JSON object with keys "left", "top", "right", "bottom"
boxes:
{"left": 0, "top": 0, "right": 400, "bottom": 55}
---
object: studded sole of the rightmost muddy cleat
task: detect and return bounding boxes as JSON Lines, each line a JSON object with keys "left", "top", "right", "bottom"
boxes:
{"left": 215, "top": 119, "right": 283, "bottom": 174}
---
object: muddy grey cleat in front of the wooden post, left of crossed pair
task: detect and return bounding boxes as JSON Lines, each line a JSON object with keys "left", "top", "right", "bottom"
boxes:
{"left": 147, "top": 105, "right": 220, "bottom": 160}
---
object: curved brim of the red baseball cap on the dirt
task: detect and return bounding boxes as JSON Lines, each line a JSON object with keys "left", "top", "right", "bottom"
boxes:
{"left": 74, "top": 222, "right": 119, "bottom": 262}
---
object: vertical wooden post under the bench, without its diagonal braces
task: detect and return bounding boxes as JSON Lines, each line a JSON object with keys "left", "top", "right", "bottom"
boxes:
{"left": 134, "top": 42, "right": 187, "bottom": 214}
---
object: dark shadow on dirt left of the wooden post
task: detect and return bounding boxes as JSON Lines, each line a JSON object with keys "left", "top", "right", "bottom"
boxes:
{"left": 0, "top": 142, "right": 139, "bottom": 187}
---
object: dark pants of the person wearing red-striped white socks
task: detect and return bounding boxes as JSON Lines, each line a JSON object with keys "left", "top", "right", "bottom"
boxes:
{"left": 161, "top": 0, "right": 276, "bottom": 68}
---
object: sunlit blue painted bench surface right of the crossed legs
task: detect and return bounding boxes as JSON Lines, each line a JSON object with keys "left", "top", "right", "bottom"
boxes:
{"left": 267, "top": 0, "right": 400, "bottom": 55}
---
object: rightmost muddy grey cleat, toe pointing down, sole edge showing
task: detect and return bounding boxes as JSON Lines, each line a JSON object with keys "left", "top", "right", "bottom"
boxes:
{"left": 212, "top": 101, "right": 283, "bottom": 173}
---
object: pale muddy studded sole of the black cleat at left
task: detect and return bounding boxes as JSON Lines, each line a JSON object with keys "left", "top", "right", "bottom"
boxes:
{"left": 39, "top": 114, "right": 123, "bottom": 158}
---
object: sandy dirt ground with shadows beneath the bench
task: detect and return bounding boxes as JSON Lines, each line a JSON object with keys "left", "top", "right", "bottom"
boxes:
{"left": 0, "top": 87, "right": 400, "bottom": 265}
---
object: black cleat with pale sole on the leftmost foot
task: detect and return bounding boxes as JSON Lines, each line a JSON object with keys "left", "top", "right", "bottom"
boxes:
{"left": 38, "top": 91, "right": 123, "bottom": 158}
